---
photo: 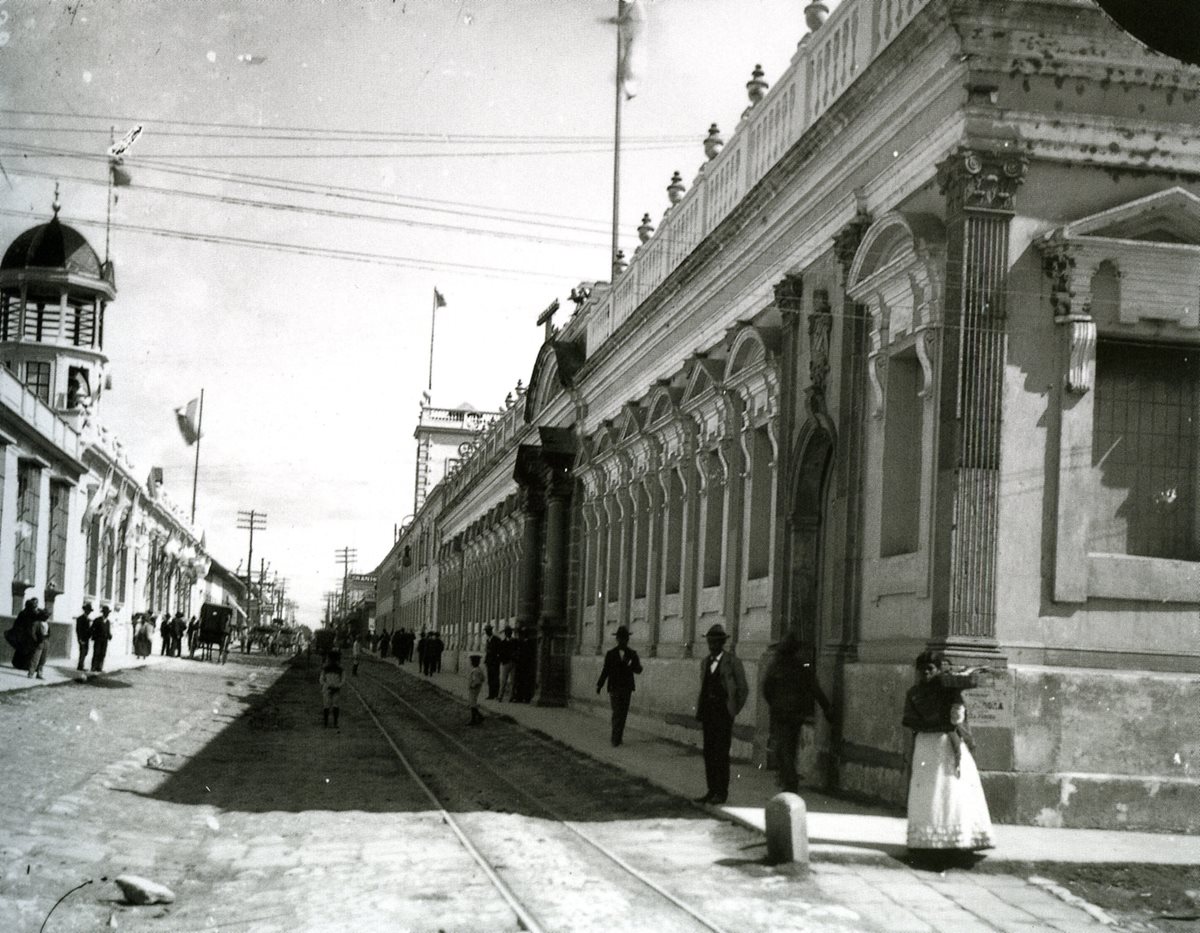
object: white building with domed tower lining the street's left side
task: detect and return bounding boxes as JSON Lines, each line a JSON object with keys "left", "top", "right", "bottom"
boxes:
{"left": 0, "top": 205, "right": 240, "bottom": 657}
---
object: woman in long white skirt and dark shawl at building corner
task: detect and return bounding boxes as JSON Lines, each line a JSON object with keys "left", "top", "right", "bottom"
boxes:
{"left": 902, "top": 651, "right": 994, "bottom": 861}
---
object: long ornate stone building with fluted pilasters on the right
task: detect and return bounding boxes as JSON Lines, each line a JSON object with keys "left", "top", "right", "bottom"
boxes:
{"left": 374, "top": 0, "right": 1200, "bottom": 830}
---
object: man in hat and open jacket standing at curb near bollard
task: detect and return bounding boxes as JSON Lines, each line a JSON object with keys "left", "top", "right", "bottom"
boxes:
{"left": 696, "top": 625, "right": 750, "bottom": 803}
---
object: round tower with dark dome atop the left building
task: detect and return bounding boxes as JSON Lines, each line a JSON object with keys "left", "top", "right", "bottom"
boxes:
{"left": 0, "top": 193, "right": 116, "bottom": 420}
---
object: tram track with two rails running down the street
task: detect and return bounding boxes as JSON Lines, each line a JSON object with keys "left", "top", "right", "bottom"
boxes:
{"left": 349, "top": 674, "right": 726, "bottom": 933}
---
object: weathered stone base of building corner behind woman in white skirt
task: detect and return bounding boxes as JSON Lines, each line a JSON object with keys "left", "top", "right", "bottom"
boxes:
{"left": 836, "top": 664, "right": 1200, "bottom": 832}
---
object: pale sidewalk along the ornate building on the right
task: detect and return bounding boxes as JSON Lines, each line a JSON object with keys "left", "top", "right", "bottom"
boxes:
{"left": 398, "top": 661, "right": 1200, "bottom": 865}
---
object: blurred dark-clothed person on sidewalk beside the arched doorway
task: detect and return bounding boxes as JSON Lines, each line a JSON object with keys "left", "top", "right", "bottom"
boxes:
{"left": 762, "top": 631, "right": 833, "bottom": 794}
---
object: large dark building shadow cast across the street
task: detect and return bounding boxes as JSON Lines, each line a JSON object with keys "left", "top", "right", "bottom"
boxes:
{"left": 131, "top": 662, "right": 709, "bottom": 821}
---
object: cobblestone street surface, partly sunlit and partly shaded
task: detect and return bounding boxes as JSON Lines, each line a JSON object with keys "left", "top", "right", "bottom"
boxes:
{"left": 0, "top": 656, "right": 1142, "bottom": 933}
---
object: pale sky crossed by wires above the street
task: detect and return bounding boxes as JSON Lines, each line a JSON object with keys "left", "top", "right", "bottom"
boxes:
{"left": 0, "top": 0, "right": 836, "bottom": 624}
